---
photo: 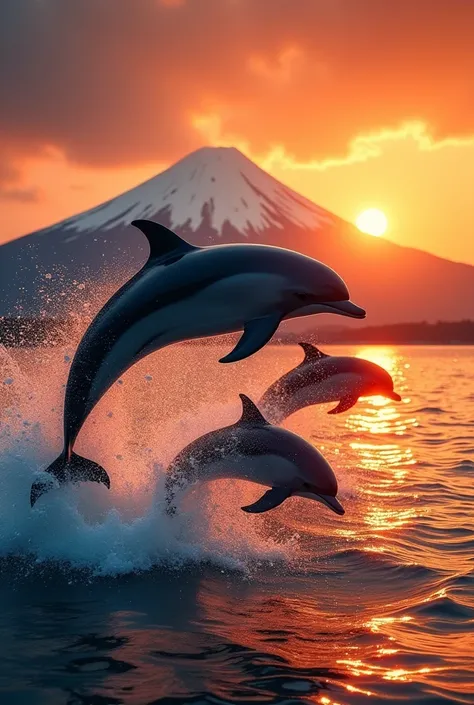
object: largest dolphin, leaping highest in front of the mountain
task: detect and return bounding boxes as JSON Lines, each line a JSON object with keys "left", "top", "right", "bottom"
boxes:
{"left": 30, "top": 220, "right": 365, "bottom": 506}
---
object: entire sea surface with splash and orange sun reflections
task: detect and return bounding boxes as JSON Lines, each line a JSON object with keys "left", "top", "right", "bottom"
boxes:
{"left": 0, "top": 346, "right": 474, "bottom": 705}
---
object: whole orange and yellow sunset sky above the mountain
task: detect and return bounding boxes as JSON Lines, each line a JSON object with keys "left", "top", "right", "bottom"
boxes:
{"left": 0, "top": 0, "right": 474, "bottom": 264}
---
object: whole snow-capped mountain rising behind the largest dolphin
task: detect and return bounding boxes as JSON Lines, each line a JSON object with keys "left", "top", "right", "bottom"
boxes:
{"left": 0, "top": 147, "right": 474, "bottom": 327}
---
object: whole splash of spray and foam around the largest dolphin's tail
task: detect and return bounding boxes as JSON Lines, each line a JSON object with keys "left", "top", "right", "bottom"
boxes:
{"left": 0, "top": 342, "right": 304, "bottom": 575}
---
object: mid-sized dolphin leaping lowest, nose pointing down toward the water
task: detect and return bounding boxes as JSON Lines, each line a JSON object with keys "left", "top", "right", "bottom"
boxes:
{"left": 165, "top": 394, "right": 344, "bottom": 515}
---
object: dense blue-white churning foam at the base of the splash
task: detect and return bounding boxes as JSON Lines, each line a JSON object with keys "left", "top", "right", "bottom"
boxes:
{"left": 0, "top": 429, "right": 295, "bottom": 576}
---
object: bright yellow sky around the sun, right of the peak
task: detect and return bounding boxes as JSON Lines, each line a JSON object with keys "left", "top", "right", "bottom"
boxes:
{"left": 262, "top": 123, "right": 474, "bottom": 264}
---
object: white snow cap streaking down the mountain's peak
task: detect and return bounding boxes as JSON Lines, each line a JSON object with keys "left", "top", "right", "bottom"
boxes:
{"left": 56, "top": 147, "right": 336, "bottom": 241}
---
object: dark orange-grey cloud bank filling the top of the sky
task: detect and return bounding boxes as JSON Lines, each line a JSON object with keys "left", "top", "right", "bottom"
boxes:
{"left": 0, "top": 0, "right": 474, "bottom": 183}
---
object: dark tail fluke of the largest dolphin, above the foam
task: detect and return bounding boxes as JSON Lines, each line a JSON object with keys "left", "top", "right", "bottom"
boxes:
{"left": 30, "top": 453, "right": 110, "bottom": 507}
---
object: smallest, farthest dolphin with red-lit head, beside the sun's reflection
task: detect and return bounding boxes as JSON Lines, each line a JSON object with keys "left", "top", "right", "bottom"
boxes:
{"left": 259, "top": 343, "right": 401, "bottom": 423}
